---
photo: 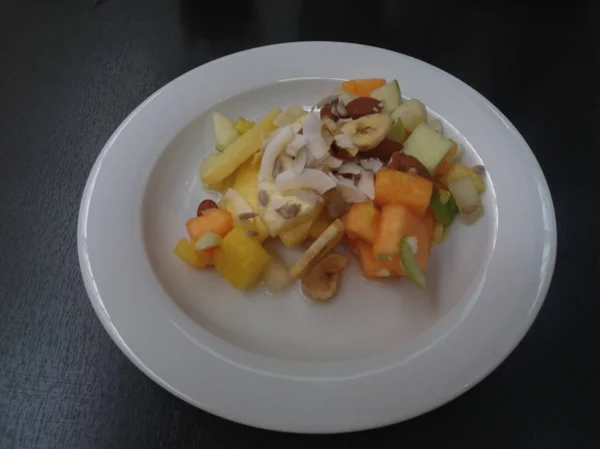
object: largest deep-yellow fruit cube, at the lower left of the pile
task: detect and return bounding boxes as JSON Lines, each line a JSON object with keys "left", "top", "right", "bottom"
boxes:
{"left": 215, "top": 228, "right": 271, "bottom": 290}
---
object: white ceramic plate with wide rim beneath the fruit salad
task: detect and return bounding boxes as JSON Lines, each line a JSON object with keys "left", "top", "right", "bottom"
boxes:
{"left": 78, "top": 42, "right": 556, "bottom": 432}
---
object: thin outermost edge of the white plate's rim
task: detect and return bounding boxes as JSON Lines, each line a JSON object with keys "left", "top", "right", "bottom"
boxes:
{"left": 77, "top": 41, "right": 557, "bottom": 433}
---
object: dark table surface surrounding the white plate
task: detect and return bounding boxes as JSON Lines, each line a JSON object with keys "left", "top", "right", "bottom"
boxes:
{"left": 0, "top": 0, "right": 600, "bottom": 449}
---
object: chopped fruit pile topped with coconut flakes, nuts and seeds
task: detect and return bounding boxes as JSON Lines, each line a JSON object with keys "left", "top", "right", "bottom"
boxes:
{"left": 174, "top": 78, "right": 485, "bottom": 301}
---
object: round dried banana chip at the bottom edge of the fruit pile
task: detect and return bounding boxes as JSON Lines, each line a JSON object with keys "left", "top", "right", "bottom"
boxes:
{"left": 302, "top": 254, "right": 348, "bottom": 301}
